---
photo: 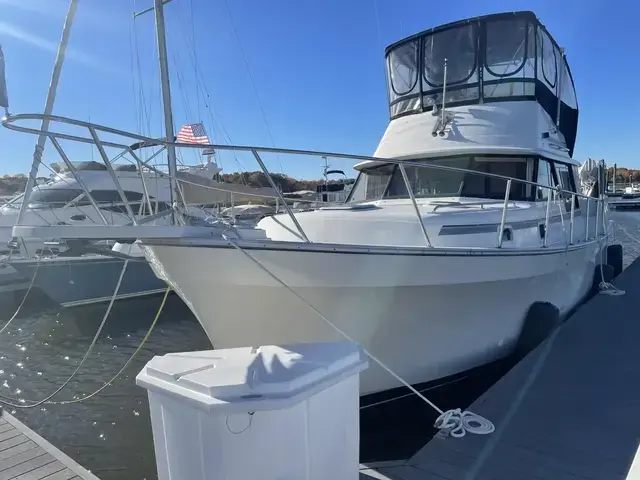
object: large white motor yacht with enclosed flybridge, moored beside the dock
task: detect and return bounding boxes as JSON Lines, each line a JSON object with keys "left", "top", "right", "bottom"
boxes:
{"left": 3, "top": 9, "right": 610, "bottom": 395}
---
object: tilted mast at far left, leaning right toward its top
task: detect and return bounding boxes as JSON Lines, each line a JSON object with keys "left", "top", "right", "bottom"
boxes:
{"left": 16, "top": 0, "right": 78, "bottom": 225}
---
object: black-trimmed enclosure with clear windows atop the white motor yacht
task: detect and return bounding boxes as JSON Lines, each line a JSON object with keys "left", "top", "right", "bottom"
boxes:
{"left": 385, "top": 11, "right": 578, "bottom": 155}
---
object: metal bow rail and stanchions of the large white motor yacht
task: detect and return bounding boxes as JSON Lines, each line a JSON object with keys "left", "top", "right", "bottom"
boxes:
{"left": 1, "top": 113, "right": 608, "bottom": 248}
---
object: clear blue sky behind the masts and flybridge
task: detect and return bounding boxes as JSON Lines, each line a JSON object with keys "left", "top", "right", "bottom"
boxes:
{"left": 0, "top": 0, "right": 640, "bottom": 177}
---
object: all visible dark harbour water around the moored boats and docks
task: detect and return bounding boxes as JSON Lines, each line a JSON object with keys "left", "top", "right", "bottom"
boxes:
{"left": 0, "top": 212, "right": 640, "bottom": 480}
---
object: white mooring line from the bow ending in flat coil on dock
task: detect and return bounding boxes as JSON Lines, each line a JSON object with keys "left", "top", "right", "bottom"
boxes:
{"left": 222, "top": 234, "right": 495, "bottom": 438}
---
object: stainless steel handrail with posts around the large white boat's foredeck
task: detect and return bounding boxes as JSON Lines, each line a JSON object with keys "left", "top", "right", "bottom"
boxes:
{"left": 1, "top": 110, "right": 606, "bottom": 248}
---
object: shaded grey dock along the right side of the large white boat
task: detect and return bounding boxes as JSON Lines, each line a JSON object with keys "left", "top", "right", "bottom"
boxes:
{"left": 360, "top": 260, "right": 640, "bottom": 480}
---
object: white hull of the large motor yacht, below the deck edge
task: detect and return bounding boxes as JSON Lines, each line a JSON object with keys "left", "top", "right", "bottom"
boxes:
{"left": 145, "top": 241, "right": 599, "bottom": 395}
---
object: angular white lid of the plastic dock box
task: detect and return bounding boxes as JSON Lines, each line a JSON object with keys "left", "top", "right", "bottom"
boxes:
{"left": 136, "top": 342, "right": 367, "bottom": 411}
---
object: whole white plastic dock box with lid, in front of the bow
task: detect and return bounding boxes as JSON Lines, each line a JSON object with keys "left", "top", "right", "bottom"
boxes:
{"left": 136, "top": 342, "right": 367, "bottom": 480}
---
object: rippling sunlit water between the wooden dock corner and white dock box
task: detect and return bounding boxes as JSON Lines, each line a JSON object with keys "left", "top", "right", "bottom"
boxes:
{"left": 0, "top": 294, "right": 211, "bottom": 480}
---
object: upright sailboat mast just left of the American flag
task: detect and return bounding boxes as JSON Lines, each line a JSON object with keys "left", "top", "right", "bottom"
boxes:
{"left": 154, "top": 0, "right": 178, "bottom": 205}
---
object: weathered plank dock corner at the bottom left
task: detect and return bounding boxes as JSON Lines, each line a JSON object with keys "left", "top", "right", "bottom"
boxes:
{"left": 0, "top": 411, "right": 99, "bottom": 480}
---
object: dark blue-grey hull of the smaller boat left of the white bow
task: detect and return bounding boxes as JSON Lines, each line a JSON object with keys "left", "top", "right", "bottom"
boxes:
{"left": 10, "top": 255, "right": 166, "bottom": 307}
